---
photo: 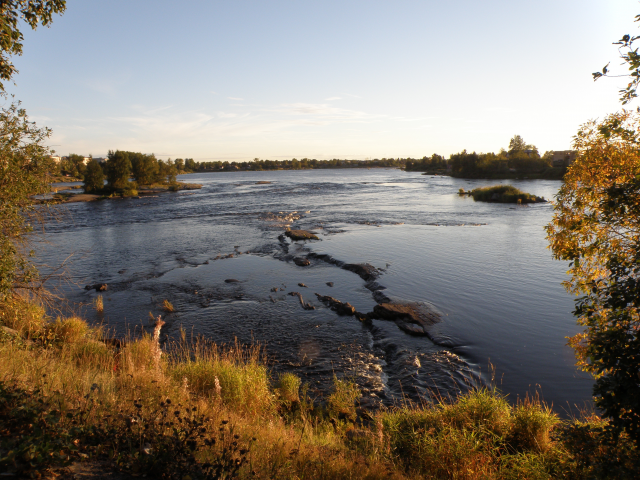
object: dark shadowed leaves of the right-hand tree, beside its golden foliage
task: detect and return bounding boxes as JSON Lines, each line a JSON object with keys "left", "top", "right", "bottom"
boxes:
{"left": 572, "top": 177, "right": 640, "bottom": 445}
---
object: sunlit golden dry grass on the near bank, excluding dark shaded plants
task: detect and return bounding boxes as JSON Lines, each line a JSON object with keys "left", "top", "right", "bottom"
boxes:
{"left": 0, "top": 298, "right": 632, "bottom": 480}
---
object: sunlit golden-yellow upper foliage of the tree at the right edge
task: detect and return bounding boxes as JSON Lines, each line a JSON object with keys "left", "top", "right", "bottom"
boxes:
{"left": 546, "top": 112, "right": 640, "bottom": 293}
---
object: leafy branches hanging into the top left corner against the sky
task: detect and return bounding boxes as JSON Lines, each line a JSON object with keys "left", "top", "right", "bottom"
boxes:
{"left": 0, "top": 0, "right": 66, "bottom": 92}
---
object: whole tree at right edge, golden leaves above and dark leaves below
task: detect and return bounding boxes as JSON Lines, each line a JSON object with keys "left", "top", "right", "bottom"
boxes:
{"left": 546, "top": 111, "right": 640, "bottom": 445}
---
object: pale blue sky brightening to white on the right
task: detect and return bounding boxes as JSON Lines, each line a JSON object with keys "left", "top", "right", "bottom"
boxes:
{"left": 5, "top": 0, "right": 640, "bottom": 161}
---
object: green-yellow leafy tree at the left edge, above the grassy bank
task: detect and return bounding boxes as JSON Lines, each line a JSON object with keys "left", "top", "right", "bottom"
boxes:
{"left": 0, "top": 103, "right": 54, "bottom": 300}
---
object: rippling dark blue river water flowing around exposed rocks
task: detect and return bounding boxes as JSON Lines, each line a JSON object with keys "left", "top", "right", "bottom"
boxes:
{"left": 38, "top": 169, "right": 592, "bottom": 412}
